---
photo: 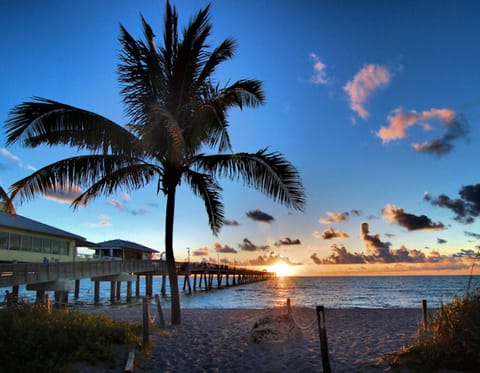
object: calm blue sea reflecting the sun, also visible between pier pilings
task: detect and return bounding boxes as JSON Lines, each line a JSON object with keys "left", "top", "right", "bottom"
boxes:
{"left": 1, "top": 276, "right": 480, "bottom": 309}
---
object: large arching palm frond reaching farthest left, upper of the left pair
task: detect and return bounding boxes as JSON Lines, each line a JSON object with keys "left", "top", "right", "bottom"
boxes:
{"left": 5, "top": 97, "right": 137, "bottom": 155}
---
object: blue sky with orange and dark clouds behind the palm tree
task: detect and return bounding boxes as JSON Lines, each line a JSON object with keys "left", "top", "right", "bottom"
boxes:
{"left": 0, "top": 0, "right": 480, "bottom": 274}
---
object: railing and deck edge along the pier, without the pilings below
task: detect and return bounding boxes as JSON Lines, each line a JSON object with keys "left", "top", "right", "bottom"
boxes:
{"left": 0, "top": 260, "right": 272, "bottom": 287}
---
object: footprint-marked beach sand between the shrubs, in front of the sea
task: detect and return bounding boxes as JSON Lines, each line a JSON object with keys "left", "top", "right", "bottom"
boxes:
{"left": 83, "top": 304, "right": 421, "bottom": 373}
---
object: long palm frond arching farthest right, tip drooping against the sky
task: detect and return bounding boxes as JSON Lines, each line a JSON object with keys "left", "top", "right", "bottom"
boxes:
{"left": 193, "top": 149, "right": 305, "bottom": 211}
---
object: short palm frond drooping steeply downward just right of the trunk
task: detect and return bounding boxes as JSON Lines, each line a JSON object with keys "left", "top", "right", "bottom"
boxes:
{"left": 184, "top": 170, "right": 224, "bottom": 235}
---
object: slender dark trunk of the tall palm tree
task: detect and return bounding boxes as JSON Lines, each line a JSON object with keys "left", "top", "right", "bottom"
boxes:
{"left": 165, "top": 186, "right": 182, "bottom": 325}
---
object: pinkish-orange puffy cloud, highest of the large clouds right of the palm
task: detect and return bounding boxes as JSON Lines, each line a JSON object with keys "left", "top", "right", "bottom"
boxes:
{"left": 343, "top": 64, "right": 392, "bottom": 119}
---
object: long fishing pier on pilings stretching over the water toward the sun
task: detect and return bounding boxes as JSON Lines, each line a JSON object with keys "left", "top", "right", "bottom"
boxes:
{"left": 0, "top": 260, "right": 275, "bottom": 304}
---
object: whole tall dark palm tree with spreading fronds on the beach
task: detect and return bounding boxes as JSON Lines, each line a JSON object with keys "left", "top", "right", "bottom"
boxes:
{"left": 5, "top": 2, "right": 305, "bottom": 324}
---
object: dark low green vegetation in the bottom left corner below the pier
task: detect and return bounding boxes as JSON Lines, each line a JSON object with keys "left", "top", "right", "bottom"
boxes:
{"left": 0, "top": 305, "right": 139, "bottom": 372}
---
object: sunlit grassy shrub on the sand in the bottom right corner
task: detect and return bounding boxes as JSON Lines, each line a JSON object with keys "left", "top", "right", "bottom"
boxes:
{"left": 399, "top": 291, "right": 480, "bottom": 371}
